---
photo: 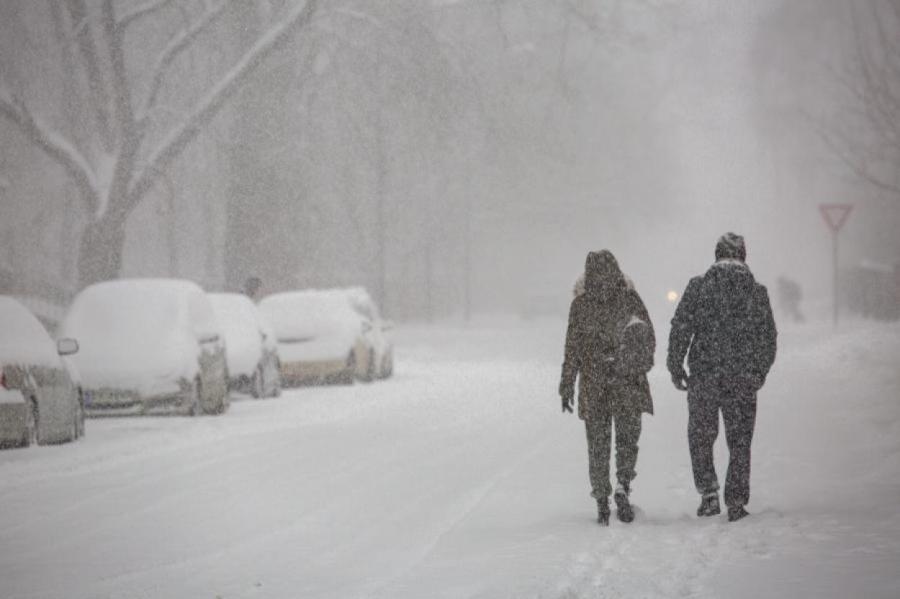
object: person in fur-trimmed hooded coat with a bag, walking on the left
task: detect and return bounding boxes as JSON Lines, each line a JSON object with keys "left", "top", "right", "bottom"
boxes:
{"left": 559, "top": 250, "right": 656, "bottom": 525}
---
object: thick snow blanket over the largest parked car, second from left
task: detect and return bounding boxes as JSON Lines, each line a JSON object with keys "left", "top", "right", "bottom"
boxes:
{"left": 61, "top": 279, "right": 219, "bottom": 394}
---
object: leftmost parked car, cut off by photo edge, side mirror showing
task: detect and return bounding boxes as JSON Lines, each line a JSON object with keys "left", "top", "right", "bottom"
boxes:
{"left": 0, "top": 296, "right": 84, "bottom": 446}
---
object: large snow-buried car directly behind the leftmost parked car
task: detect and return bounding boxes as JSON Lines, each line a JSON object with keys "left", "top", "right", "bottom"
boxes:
{"left": 61, "top": 279, "right": 228, "bottom": 416}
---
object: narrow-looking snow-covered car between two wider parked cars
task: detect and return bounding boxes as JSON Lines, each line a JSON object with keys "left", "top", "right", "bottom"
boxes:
{"left": 208, "top": 293, "right": 281, "bottom": 397}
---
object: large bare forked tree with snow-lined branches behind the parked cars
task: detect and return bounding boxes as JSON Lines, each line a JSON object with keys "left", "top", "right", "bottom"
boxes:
{"left": 0, "top": 0, "right": 318, "bottom": 285}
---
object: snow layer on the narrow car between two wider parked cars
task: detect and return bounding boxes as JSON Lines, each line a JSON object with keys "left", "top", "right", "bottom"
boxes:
{"left": 208, "top": 293, "right": 270, "bottom": 376}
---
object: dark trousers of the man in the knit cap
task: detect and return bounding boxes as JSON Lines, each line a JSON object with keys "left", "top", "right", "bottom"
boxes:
{"left": 688, "top": 380, "right": 756, "bottom": 507}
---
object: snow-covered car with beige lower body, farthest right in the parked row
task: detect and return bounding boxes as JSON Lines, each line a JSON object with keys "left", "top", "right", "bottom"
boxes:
{"left": 259, "top": 290, "right": 369, "bottom": 385}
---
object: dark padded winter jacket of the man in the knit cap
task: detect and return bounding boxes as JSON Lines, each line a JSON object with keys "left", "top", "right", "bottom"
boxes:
{"left": 667, "top": 259, "right": 777, "bottom": 393}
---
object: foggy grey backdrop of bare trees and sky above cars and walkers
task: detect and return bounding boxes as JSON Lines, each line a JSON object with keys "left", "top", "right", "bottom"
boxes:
{"left": 0, "top": 0, "right": 900, "bottom": 322}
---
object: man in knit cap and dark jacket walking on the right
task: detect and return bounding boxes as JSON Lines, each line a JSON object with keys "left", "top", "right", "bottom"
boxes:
{"left": 667, "top": 233, "right": 777, "bottom": 522}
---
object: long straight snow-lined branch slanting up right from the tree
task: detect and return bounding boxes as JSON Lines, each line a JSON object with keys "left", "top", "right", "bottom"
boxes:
{"left": 126, "top": 0, "right": 318, "bottom": 214}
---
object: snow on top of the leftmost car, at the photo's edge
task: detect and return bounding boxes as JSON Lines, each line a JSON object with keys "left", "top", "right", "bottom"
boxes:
{"left": 0, "top": 295, "right": 60, "bottom": 368}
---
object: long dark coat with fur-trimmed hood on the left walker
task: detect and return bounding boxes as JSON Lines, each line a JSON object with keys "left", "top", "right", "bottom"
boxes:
{"left": 559, "top": 250, "right": 656, "bottom": 420}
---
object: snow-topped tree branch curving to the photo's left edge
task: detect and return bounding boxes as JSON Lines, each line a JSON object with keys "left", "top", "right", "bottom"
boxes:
{"left": 0, "top": 92, "right": 99, "bottom": 214}
